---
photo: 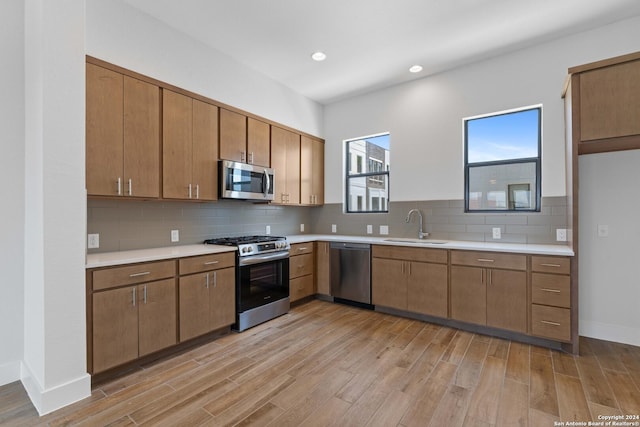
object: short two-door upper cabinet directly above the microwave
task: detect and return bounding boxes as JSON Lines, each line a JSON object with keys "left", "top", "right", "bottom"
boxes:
{"left": 220, "top": 108, "right": 270, "bottom": 167}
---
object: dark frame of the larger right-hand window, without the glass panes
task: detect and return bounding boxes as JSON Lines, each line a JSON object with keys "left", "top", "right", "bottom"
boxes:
{"left": 462, "top": 104, "right": 543, "bottom": 213}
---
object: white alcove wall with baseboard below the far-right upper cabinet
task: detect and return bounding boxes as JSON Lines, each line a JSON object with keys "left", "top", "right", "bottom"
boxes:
{"left": 579, "top": 150, "right": 640, "bottom": 346}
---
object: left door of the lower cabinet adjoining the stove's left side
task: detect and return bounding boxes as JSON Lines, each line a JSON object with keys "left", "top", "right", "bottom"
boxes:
{"left": 179, "top": 273, "right": 211, "bottom": 341}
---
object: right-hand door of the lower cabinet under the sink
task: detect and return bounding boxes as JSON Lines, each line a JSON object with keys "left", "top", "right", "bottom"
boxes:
{"left": 407, "top": 262, "right": 449, "bottom": 318}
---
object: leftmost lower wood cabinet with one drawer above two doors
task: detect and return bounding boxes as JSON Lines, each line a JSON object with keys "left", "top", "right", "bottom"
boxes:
{"left": 89, "top": 261, "right": 177, "bottom": 373}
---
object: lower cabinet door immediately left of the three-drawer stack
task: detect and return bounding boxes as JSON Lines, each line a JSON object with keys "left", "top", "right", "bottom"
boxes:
{"left": 487, "top": 270, "right": 527, "bottom": 333}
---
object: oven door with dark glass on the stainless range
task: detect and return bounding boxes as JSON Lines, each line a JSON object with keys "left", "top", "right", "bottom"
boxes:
{"left": 236, "top": 251, "right": 289, "bottom": 314}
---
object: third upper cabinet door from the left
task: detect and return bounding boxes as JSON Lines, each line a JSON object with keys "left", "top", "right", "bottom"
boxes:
{"left": 162, "top": 89, "right": 193, "bottom": 199}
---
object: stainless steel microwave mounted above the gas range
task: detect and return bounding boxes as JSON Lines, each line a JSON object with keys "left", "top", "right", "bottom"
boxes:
{"left": 219, "top": 160, "right": 274, "bottom": 201}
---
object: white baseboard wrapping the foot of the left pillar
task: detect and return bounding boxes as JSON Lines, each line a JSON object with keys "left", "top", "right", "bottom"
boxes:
{"left": 21, "top": 363, "right": 91, "bottom": 415}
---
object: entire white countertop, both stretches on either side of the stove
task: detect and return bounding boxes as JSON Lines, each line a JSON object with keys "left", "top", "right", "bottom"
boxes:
{"left": 85, "top": 234, "right": 574, "bottom": 268}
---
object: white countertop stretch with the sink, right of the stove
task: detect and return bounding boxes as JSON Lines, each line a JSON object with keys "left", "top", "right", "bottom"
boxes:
{"left": 287, "top": 234, "right": 575, "bottom": 256}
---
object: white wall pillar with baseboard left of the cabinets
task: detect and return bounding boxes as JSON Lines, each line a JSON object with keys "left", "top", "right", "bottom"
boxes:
{"left": 21, "top": 0, "right": 91, "bottom": 414}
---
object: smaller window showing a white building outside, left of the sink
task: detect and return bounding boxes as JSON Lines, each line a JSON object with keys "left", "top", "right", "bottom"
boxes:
{"left": 345, "top": 134, "right": 389, "bottom": 213}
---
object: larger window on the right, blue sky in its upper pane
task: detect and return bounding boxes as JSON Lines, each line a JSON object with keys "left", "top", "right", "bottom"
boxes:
{"left": 464, "top": 106, "right": 542, "bottom": 212}
